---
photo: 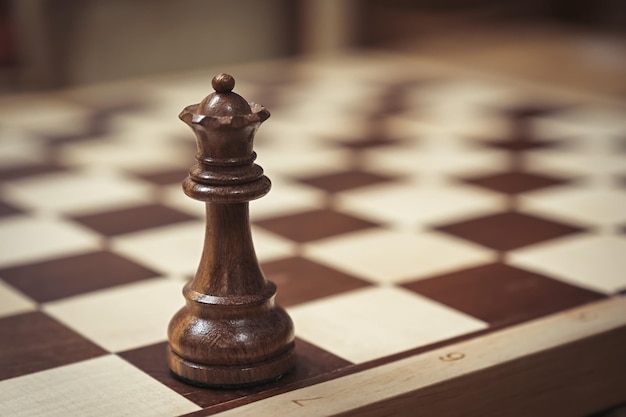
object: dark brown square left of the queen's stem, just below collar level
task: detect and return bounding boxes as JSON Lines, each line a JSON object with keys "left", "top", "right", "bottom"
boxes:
{"left": 73, "top": 204, "right": 197, "bottom": 236}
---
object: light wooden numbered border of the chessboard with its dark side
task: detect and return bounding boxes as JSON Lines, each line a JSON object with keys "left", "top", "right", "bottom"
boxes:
{"left": 199, "top": 297, "right": 626, "bottom": 417}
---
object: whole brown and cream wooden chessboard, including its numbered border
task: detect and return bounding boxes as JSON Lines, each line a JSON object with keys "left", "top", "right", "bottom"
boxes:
{"left": 0, "top": 52, "right": 626, "bottom": 416}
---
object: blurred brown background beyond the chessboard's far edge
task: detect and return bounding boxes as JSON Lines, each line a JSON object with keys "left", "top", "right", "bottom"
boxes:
{"left": 0, "top": 0, "right": 626, "bottom": 97}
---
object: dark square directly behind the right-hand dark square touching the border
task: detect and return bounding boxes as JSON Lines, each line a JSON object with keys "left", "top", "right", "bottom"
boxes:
{"left": 436, "top": 212, "right": 584, "bottom": 251}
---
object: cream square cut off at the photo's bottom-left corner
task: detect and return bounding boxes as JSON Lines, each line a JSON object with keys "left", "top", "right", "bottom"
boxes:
{"left": 0, "top": 355, "right": 200, "bottom": 417}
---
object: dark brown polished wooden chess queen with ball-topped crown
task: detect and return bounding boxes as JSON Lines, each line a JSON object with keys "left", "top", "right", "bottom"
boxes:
{"left": 168, "top": 74, "right": 295, "bottom": 388}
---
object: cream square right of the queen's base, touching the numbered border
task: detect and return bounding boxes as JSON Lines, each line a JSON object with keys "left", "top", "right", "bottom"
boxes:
{"left": 288, "top": 287, "right": 487, "bottom": 363}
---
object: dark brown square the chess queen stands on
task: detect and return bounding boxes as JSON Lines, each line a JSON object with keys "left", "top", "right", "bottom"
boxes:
{"left": 119, "top": 339, "right": 352, "bottom": 408}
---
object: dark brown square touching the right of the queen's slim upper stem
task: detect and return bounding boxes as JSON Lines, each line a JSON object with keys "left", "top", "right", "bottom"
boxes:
{"left": 255, "top": 209, "right": 378, "bottom": 243}
